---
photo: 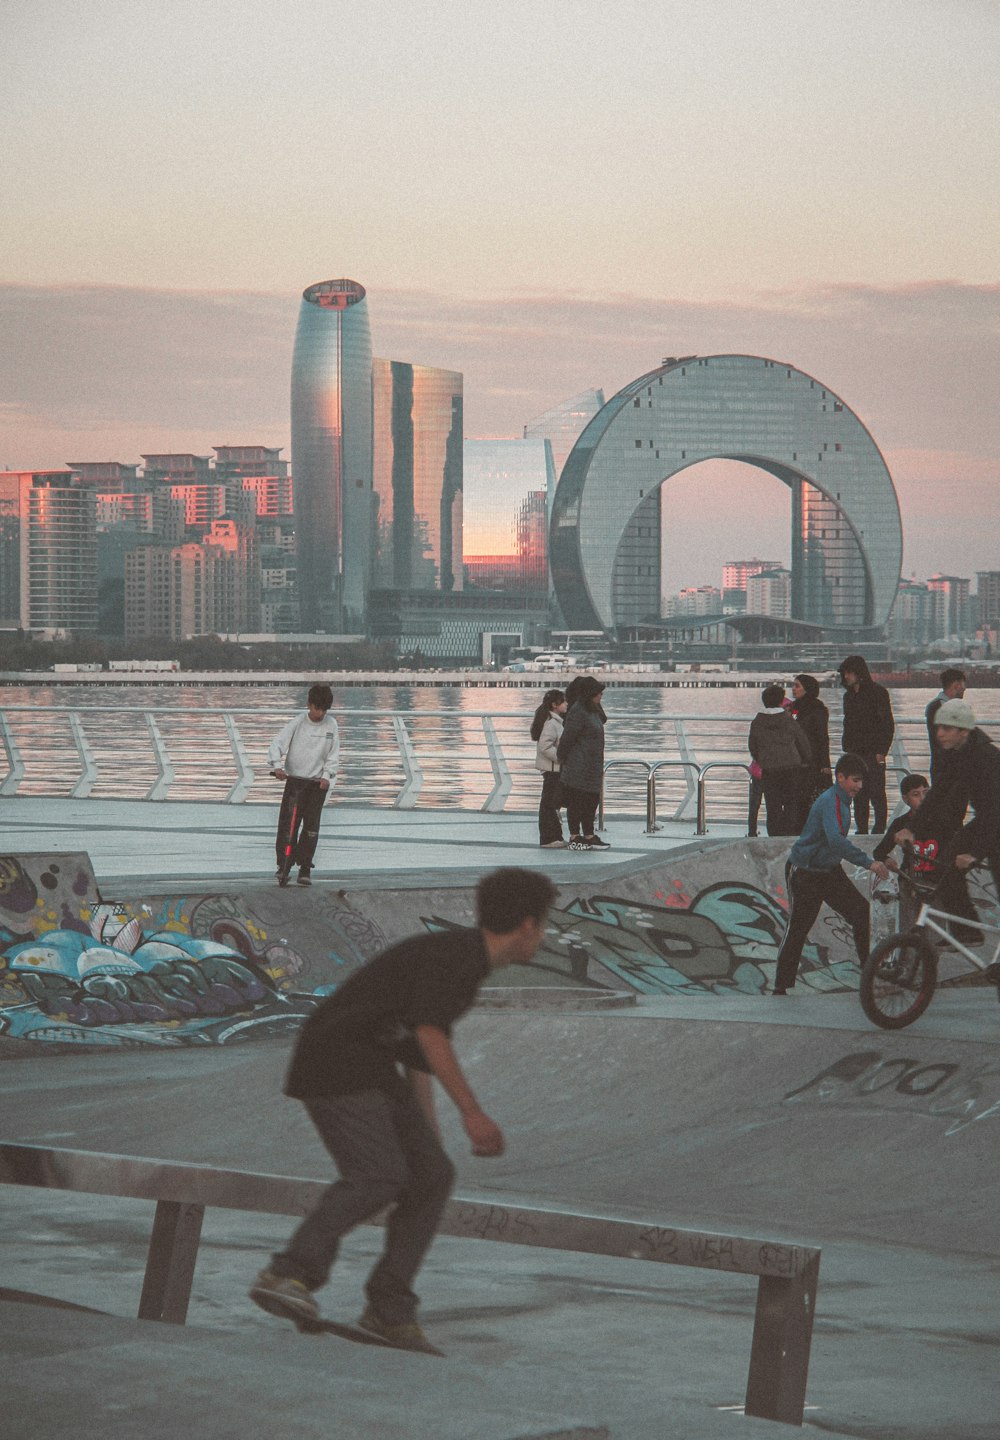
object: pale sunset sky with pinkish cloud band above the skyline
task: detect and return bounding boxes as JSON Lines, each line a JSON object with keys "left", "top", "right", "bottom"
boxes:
{"left": 0, "top": 0, "right": 1000, "bottom": 589}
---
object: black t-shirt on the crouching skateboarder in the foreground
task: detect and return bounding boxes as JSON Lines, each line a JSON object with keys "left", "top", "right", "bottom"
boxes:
{"left": 285, "top": 929, "right": 490, "bottom": 1100}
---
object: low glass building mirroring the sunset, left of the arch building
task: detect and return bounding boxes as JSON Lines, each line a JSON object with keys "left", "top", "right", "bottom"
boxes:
{"left": 463, "top": 439, "right": 555, "bottom": 593}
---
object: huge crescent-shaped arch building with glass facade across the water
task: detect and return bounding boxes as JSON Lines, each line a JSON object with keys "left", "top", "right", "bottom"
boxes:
{"left": 549, "top": 354, "right": 902, "bottom": 632}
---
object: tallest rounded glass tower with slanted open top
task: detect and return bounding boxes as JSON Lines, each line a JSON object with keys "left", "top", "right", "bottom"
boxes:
{"left": 291, "top": 279, "right": 375, "bottom": 634}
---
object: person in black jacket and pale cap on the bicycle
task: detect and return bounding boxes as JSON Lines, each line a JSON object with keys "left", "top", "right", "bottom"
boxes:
{"left": 896, "top": 700, "right": 1000, "bottom": 945}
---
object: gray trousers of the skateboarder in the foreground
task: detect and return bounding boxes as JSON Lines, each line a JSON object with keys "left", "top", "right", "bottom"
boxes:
{"left": 271, "top": 1090, "right": 455, "bottom": 1325}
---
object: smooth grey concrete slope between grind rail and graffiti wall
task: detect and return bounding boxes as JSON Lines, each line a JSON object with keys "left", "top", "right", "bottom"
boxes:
{"left": 4, "top": 1001, "right": 1000, "bottom": 1257}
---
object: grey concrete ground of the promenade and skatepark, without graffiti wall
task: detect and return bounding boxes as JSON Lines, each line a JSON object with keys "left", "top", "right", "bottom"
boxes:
{"left": 0, "top": 801, "right": 1000, "bottom": 1440}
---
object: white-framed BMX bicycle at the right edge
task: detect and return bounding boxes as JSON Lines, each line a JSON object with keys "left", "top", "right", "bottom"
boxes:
{"left": 860, "top": 867, "right": 1000, "bottom": 1030}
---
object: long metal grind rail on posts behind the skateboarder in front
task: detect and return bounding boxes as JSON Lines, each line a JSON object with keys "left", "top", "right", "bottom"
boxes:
{"left": 0, "top": 1143, "right": 820, "bottom": 1426}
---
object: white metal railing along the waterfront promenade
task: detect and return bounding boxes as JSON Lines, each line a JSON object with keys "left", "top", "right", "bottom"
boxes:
{"left": 0, "top": 706, "right": 985, "bottom": 834}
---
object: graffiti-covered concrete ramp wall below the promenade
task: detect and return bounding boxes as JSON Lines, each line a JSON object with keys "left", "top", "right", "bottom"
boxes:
{"left": 0, "top": 841, "right": 997, "bottom": 1050}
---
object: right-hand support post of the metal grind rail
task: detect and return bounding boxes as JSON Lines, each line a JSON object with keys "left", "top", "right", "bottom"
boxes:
{"left": 746, "top": 1256, "right": 820, "bottom": 1426}
